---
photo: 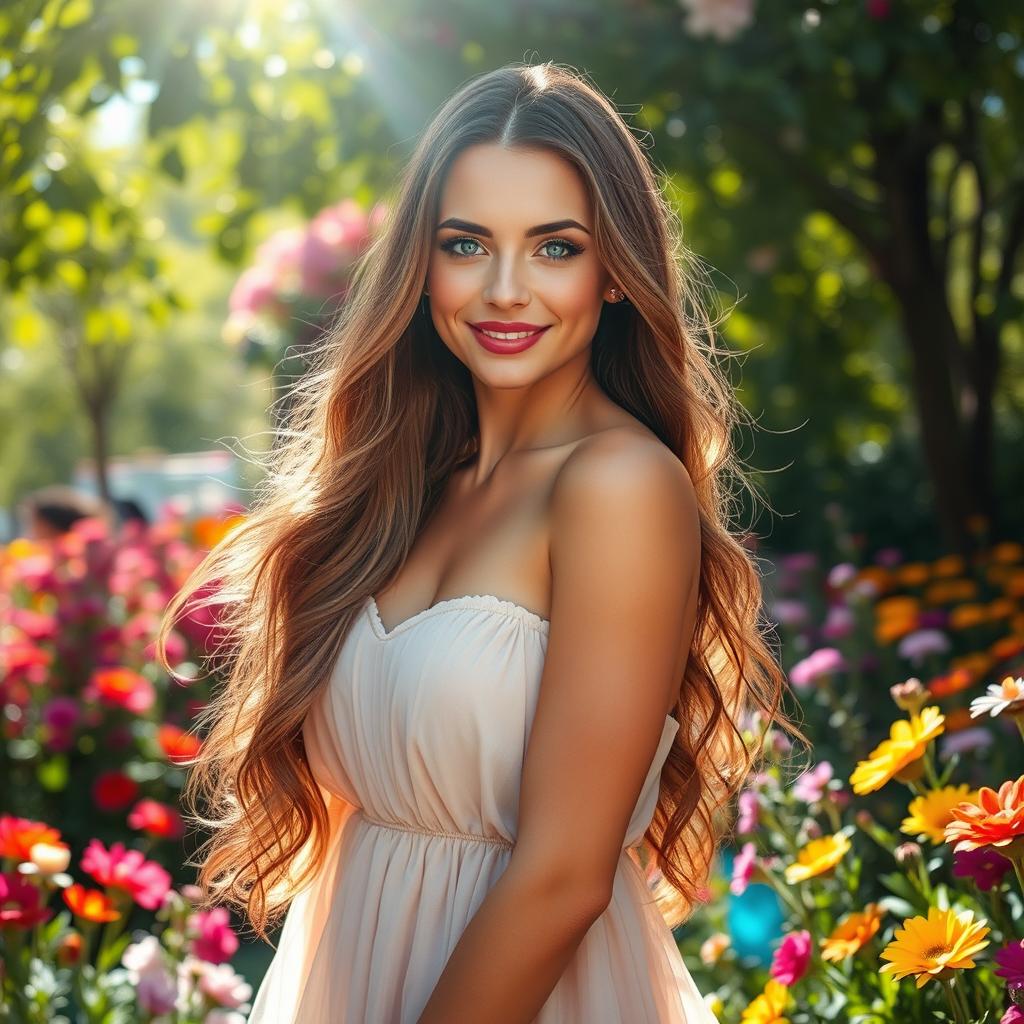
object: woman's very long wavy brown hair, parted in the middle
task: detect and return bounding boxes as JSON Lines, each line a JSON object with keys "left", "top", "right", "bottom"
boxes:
{"left": 158, "top": 62, "right": 806, "bottom": 939}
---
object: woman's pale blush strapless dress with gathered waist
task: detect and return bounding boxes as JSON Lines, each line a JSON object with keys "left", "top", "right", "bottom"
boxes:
{"left": 249, "top": 595, "right": 716, "bottom": 1024}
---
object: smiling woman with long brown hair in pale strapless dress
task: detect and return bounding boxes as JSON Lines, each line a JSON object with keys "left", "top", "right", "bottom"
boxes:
{"left": 155, "top": 63, "right": 795, "bottom": 1024}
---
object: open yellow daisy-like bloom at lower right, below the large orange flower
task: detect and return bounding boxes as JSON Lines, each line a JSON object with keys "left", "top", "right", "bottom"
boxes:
{"left": 881, "top": 906, "right": 990, "bottom": 988}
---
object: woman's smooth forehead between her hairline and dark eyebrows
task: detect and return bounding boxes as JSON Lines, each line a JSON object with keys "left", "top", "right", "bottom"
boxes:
{"left": 437, "top": 142, "right": 590, "bottom": 229}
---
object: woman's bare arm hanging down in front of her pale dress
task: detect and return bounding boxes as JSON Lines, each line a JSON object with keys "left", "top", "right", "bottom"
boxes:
{"left": 419, "top": 431, "right": 700, "bottom": 1024}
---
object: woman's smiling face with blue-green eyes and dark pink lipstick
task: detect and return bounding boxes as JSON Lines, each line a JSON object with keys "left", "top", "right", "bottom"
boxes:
{"left": 427, "top": 143, "right": 614, "bottom": 387}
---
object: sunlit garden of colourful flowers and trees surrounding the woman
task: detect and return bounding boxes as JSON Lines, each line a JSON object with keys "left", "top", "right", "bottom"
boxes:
{"left": 0, "top": 0, "right": 1024, "bottom": 1024}
